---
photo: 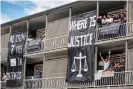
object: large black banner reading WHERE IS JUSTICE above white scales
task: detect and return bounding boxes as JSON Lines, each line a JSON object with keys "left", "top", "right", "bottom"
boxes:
{"left": 66, "top": 11, "right": 96, "bottom": 82}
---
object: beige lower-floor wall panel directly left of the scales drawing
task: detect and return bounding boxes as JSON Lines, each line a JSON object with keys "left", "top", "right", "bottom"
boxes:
{"left": 44, "top": 57, "right": 67, "bottom": 77}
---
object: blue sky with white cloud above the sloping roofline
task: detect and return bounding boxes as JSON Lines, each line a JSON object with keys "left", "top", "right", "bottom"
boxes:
{"left": 0, "top": 0, "right": 76, "bottom": 24}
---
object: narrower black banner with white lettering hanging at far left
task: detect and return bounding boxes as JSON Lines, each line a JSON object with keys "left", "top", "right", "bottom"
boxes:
{"left": 6, "top": 30, "right": 26, "bottom": 88}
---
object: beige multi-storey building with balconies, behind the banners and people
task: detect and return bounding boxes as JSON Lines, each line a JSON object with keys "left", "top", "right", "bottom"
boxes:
{"left": 1, "top": 0, "right": 133, "bottom": 89}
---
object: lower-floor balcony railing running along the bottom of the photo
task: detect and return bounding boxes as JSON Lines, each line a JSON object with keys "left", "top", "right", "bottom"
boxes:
{"left": 1, "top": 71, "right": 133, "bottom": 89}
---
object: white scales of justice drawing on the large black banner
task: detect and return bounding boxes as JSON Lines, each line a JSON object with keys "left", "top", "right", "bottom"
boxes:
{"left": 71, "top": 52, "right": 88, "bottom": 77}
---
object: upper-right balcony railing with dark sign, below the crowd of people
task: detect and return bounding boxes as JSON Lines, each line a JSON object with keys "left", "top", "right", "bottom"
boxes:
{"left": 96, "top": 22, "right": 133, "bottom": 41}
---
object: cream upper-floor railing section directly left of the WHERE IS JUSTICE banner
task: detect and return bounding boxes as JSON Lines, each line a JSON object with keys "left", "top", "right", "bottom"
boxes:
{"left": 44, "top": 35, "right": 68, "bottom": 51}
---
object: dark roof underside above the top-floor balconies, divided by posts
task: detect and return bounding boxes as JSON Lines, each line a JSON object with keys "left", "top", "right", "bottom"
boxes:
{"left": 0, "top": 1, "right": 125, "bottom": 29}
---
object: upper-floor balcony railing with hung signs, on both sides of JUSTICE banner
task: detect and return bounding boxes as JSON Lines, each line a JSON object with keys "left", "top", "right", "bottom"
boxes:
{"left": 23, "top": 22, "right": 133, "bottom": 54}
